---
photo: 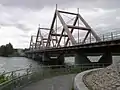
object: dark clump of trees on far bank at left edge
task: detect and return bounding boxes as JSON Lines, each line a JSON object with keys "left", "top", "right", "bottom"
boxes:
{"left": 0, "top": 43, "right": 13, "bottom": 57}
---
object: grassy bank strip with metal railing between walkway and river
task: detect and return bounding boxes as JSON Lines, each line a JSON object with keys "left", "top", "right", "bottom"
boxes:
{"left": 0, "top": 63, "right": 110, "bottom": 90}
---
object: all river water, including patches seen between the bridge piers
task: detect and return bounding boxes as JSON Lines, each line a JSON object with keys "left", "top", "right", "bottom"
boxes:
{"left": 0, "top": 56, "right": 120, "bottom": 73}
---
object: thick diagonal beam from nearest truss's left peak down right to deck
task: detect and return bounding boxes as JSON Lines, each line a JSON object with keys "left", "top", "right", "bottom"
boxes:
{"left": 56, "top": 11, "right": 76, "bottom": 45}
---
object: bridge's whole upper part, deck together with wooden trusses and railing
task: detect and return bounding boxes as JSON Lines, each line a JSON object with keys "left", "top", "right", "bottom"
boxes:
{"left": 26, "top": 9, "right": 120, "bottom": 53}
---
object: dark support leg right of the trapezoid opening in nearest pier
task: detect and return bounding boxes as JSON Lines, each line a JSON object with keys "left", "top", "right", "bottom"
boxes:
{"left": 98, "top": 51, "right": 112, "bottom": 64}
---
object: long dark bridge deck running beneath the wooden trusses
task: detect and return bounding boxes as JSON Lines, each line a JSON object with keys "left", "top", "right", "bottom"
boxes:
{"left": 26, "top": 39, "right": 120, "bottom": 53}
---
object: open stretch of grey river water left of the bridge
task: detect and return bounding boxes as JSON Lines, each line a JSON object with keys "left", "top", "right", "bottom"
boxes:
{"left": 0, "top": 57, "right": 40, "bottom": 72}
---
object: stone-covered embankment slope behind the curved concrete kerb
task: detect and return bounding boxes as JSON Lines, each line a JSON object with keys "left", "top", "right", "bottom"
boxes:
{"left": 84, "top": 65, "right": 120, "bottom": 90}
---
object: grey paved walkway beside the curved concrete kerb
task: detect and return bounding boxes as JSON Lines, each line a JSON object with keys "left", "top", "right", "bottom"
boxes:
{"left": 22, "top": 74, "right": 75, "bottom": 90}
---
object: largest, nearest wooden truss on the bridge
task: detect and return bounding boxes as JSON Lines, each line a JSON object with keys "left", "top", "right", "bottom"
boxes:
{"left": 46, "top": 10, "right": 100, "bottom": 48}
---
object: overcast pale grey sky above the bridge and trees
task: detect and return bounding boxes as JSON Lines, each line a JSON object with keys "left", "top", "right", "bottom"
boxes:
{"left": 0, "top": 0, "right": 120, "bottom": 48}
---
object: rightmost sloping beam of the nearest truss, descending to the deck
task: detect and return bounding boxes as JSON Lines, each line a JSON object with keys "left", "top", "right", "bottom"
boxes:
{"left": 78, "top": 14, "right": 101, "bottom": 41}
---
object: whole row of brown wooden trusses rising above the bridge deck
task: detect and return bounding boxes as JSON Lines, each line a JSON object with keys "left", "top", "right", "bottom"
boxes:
{"left": 30, "top": 10, "right": 101, "bottom": 49}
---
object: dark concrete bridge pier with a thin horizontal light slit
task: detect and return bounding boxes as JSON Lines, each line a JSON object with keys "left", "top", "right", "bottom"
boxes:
{"left": 42, "top": 53, "right": 64, "bottom": 65}
